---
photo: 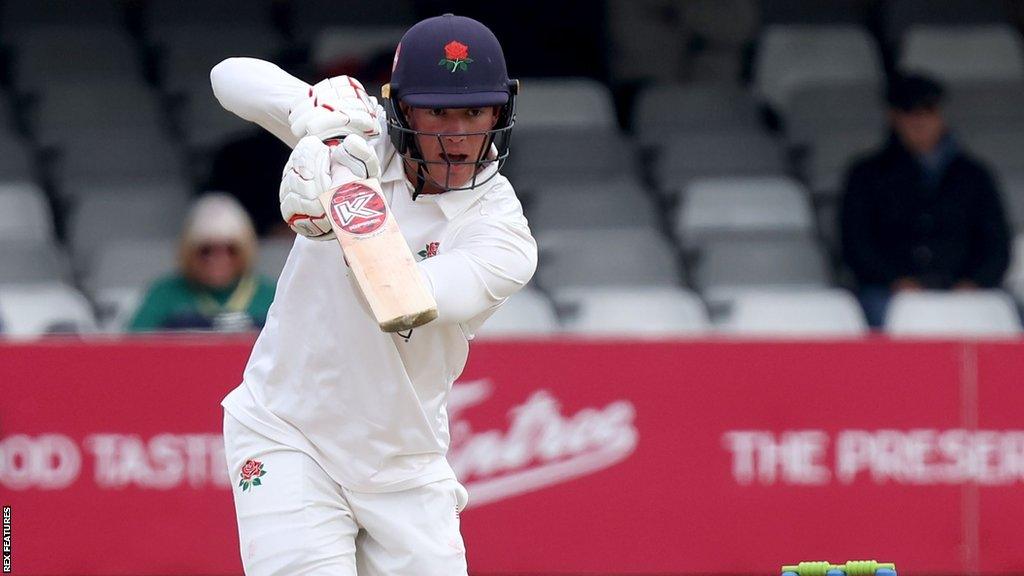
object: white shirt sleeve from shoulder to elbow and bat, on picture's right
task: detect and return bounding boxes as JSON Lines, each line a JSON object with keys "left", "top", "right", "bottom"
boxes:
{"left": 419, "top": 216, "right": 537, "bottom": 324}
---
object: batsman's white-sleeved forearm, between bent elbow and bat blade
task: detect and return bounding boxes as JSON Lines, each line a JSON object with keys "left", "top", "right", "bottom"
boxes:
{"left": 420, "top": 233, "right": 537, "bottom": 324}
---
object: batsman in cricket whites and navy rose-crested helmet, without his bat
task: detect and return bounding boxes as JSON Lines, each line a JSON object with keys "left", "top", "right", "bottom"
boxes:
{"left": 211, "top": 14, "right": 537, "bottom": 576}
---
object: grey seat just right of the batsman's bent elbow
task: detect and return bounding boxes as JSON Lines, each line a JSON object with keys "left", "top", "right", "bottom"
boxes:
{"left": 537, "top": 229, "right": 682, "bottom": 290}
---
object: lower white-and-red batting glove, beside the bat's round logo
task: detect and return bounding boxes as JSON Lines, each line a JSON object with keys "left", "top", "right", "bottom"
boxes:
{"left": 280, "top": 134, "right": 381, "bottom": 240}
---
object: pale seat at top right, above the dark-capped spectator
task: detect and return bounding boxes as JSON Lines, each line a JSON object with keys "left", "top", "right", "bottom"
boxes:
{"left": 900, "top": 25, "right": 1024, "bottom": 83}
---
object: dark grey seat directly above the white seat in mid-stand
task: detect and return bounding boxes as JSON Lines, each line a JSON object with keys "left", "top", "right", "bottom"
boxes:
{"left": 654, "top": 131, "right": 785, "bottom": 196}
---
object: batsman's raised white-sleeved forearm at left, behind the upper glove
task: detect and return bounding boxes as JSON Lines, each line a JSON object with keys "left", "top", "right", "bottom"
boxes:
{"left": 210, "top": 57, "right": 309, "bottom": 148}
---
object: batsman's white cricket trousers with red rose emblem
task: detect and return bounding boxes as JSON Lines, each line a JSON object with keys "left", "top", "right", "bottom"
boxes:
{"left": 224, "top": 413, "right": 467, "bottom": 576}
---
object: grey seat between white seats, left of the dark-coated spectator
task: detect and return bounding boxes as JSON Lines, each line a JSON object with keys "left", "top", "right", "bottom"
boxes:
{"left": 692, "top": 236, "right": 828, "bottom": 298}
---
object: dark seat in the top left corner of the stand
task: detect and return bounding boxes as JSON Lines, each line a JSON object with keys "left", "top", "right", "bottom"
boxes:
{"left": 5, "top": 25, "right": 141, "bottom": 91}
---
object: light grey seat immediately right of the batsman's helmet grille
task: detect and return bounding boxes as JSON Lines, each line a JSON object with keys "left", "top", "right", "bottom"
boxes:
{"left": 516, "top": 78, "right": 617, "bottom": 132}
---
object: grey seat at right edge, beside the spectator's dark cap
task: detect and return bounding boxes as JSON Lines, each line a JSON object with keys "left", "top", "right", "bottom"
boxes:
{"left": 945, "top": 80, "right": 1024, "bottom": 132}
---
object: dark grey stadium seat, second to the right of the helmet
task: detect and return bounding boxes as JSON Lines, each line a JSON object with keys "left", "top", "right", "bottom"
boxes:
{"left": 633, "top": 82, "right": 760, "bottom": 145}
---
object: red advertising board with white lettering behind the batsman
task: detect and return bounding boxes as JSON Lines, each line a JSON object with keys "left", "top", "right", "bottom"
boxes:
{"left": 0, "top": 339, "right": 1024, "bottom": 575}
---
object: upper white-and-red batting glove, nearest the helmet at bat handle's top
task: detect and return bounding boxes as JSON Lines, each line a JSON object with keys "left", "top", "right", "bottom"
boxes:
{"left": 288, "top": 76, "right": 380, "bottom": 140}
